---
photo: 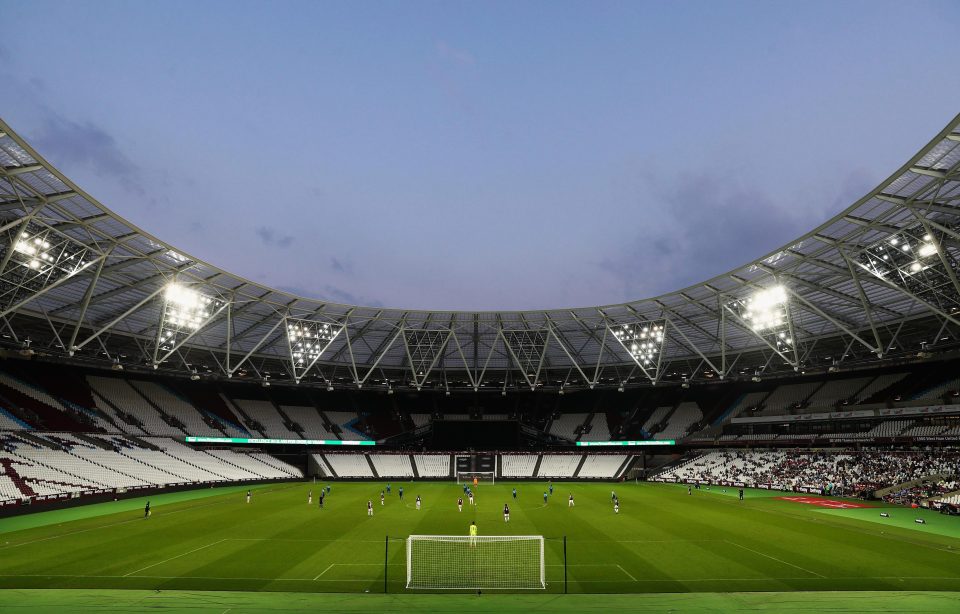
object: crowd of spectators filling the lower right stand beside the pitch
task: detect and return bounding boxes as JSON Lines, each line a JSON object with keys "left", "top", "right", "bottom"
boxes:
{"left": 654, "top": 450, "right": 960, "bottom": 496}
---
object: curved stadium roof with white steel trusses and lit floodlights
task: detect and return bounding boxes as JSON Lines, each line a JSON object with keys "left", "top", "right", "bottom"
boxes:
{"left": 0, "top": 116, "right": 960, "bottom": 388}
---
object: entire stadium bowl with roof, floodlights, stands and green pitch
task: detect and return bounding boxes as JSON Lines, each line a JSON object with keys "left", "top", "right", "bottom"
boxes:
{"left": 0, "top": 7, "right": 960, "bottom": 612}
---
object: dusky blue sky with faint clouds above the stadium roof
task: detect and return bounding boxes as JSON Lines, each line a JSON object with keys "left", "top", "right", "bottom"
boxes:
{"left": 0, "top": 0, "right": 960, "bottom": 310}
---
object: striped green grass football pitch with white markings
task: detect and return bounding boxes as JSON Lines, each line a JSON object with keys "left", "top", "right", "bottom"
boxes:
{"left": 0, "top": 481, "right": 960, "bottom": 611}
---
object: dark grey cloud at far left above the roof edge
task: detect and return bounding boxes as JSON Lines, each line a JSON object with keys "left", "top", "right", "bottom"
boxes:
{"left": 33, "top": 111, "right": 145, "bottom": 196}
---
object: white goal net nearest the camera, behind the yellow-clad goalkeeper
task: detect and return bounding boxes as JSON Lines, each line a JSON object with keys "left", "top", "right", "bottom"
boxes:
{"left": 407, "top": 535, "right": 547, "bottom": 590}
